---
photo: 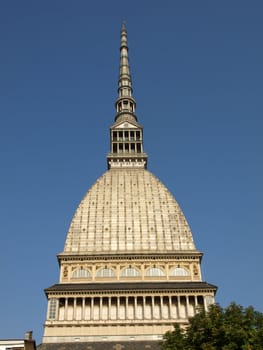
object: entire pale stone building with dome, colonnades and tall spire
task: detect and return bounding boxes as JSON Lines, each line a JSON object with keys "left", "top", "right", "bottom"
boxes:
{"left": 40, "top": 26, "right": 216, "bottom": 350}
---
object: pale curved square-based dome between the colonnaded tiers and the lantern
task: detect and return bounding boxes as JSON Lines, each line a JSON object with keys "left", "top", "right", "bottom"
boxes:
{"left": 64, "top": 169, "right": 195, "bottom": 254}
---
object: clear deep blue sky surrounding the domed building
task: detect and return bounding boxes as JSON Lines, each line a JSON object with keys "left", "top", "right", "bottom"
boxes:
{"left": 0, "top": 0, "right": 263, "bottom": 342}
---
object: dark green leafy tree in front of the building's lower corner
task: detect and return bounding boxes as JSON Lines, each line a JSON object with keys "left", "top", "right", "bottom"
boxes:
{"left": 163, "top": 303, "right": 263, "bottom": 350}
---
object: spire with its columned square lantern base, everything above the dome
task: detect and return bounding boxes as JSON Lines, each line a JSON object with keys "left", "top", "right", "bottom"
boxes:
{"left": 107, "top": 23, "right": 147, "bottom": 169}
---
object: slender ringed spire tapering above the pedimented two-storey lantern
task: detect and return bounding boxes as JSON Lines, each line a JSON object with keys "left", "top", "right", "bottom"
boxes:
{"left": 115, "top": 21, "right": 137, "bottom": 120}
